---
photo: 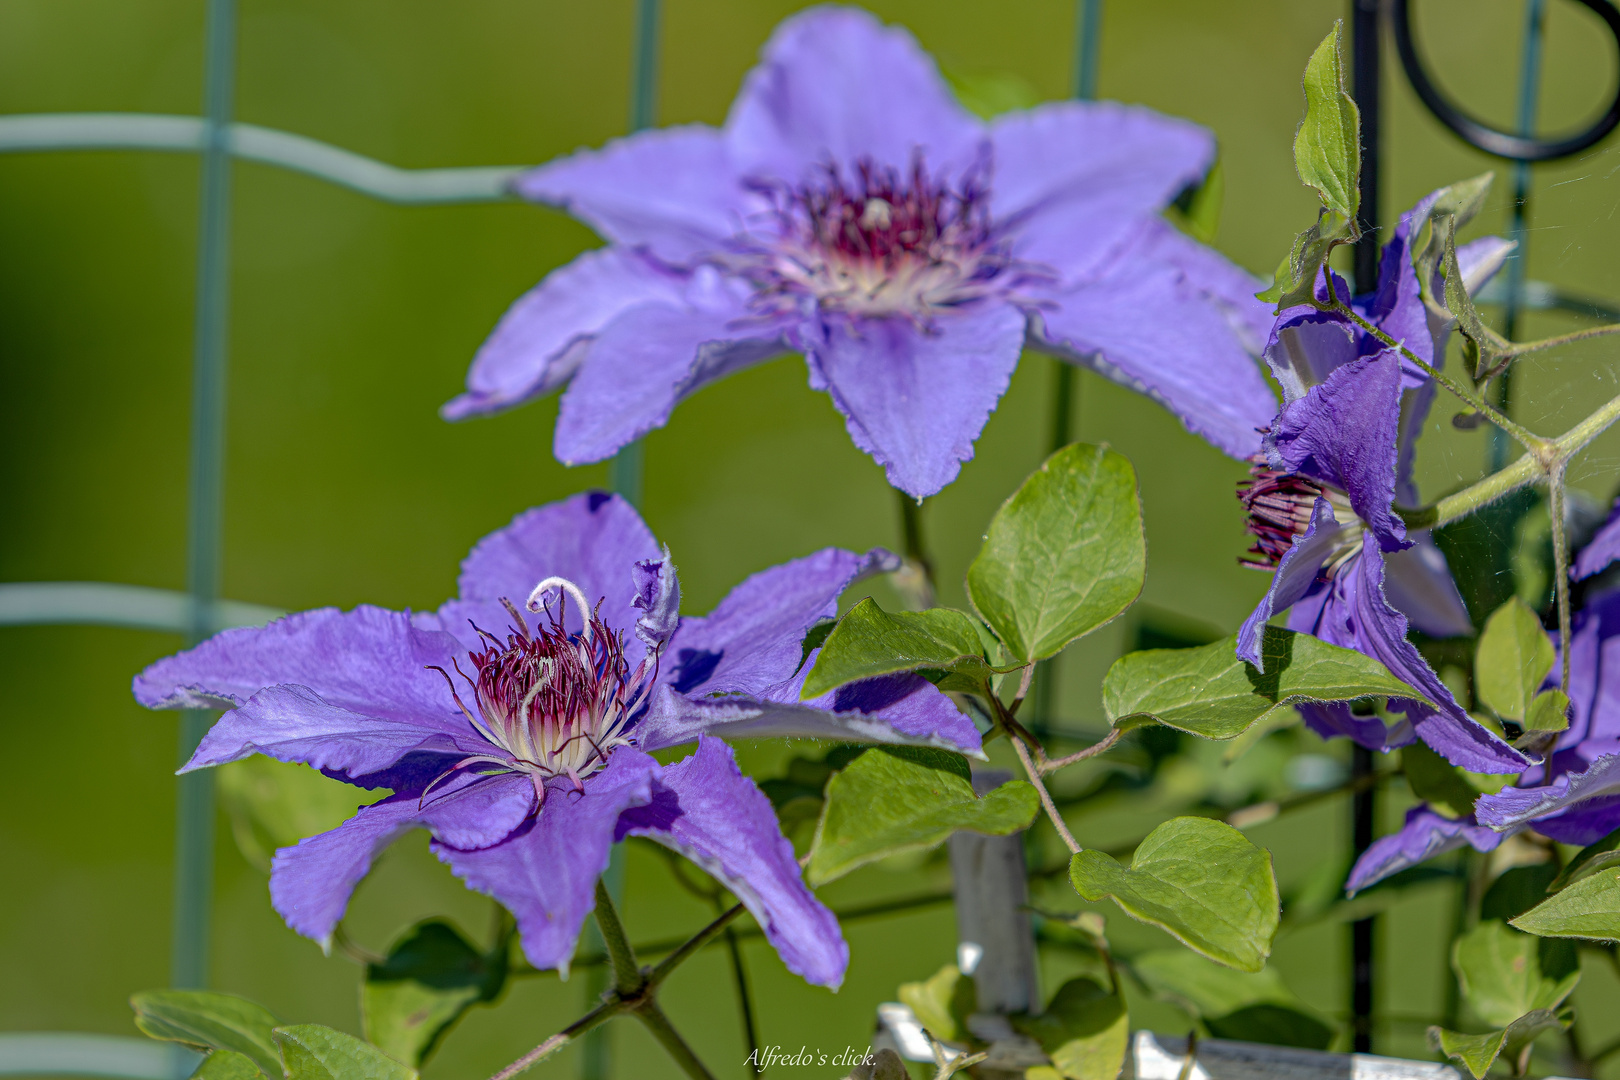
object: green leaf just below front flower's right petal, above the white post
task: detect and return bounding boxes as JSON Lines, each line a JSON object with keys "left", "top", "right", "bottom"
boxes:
{"left": 807, "top": 746, "right": 1040, "bottom": 887}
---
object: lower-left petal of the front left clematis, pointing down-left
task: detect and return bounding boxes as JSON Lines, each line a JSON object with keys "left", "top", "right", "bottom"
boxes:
{"left": 271, "top": 772, "right": 535, "bottom": 941}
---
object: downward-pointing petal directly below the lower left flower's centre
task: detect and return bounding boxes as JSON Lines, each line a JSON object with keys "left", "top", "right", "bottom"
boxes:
{"left": 433, "top": 746, "right": 661, "bottom": 972}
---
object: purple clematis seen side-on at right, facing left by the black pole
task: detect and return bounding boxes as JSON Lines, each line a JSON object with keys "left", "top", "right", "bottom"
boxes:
{"left": 1238, "top": 187, "right": 1531, "bottom": 772}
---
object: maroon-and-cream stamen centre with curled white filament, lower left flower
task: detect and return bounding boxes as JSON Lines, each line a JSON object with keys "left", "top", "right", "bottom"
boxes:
{"left": 436, "top": 578, "right": 658, "bottom": 803}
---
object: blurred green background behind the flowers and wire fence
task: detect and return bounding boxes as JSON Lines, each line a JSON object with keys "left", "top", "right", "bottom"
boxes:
{"left": 0, "top": 0, "right": 1620, "bottom": 1078}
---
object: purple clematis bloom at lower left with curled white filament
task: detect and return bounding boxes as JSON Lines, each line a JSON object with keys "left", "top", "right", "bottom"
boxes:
{"left": 134, "top": 494, "right": 978, "bottom": 986}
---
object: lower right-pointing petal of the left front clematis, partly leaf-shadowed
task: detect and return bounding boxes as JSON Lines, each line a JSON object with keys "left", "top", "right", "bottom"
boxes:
{"left": 637, "top": 670, "right": 983, "bottom": 758}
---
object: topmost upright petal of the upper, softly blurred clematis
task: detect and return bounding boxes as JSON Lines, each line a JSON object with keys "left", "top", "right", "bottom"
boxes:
{"left": 726, "top": 8, "right": 985, "bottom": 185}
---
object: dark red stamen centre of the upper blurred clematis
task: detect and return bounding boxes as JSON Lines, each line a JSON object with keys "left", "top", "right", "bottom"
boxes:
{"left": 742, "top": 157, "right": 1017, "bottom": 322}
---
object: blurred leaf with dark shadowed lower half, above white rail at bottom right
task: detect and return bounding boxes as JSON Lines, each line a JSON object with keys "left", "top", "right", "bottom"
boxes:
{"left": 1131, "top": 949, "right": 1333, "bottom": 1049}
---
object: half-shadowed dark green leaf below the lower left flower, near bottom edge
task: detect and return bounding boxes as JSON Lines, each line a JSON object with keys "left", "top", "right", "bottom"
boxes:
{"left": 360, "top": 920, "right": 507, "bottom": 1065}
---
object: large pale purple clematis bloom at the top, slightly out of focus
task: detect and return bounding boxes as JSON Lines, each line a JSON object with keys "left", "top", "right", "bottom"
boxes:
{"left": 444, "top": 8, "right": 1277, "bottom": 499}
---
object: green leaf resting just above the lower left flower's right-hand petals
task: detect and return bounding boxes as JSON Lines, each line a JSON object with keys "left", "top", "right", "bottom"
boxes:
{"left": 799, "top": 596, "right": 995, "bottom": 701}
